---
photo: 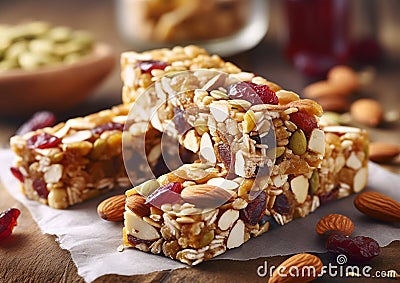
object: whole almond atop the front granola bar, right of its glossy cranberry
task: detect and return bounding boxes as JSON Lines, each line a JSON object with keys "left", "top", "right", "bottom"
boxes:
{"left": 181, "top": 184, "right": 232, "bottom": 207}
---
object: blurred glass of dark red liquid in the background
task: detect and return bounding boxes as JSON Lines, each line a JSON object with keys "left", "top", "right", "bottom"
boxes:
{"left": 284, "top": 0, "right": 351, "bottom": 76}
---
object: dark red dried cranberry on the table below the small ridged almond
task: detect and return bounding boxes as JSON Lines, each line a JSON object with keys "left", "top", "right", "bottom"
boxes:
{"left": 326, "top": 233, "right": 380, "bottom": 263}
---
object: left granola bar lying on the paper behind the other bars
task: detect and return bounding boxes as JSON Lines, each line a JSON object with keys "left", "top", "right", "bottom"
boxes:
{"left": 10, "top": 105, "right": 161, "bottom": 208}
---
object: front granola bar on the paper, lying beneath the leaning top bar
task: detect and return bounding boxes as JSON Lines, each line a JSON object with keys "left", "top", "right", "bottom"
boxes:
{"left": 123, "top": 127, "right": 368, "bottom": 265}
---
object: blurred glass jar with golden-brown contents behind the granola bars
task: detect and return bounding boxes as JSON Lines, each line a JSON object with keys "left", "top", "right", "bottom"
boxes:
{"left": 116, "top": 0, "right": 268, "bottom": 56}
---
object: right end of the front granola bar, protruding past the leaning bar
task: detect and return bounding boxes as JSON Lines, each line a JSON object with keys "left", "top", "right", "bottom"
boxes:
{"left": 317, "top": 126, "right": 369, "bottom": 199}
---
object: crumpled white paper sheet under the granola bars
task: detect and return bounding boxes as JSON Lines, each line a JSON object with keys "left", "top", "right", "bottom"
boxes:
{"left": 0, "top": 149, "right": 400, "bottom": 282}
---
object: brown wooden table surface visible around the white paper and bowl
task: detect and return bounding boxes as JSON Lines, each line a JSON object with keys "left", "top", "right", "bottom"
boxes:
{"left": 0, "top": 0, "right": 400, "bottom": 283}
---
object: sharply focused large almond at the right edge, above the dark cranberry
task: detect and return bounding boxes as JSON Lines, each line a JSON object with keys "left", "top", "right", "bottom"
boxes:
{"left": 354, "top": 192, "right": 400, "bottom": 222}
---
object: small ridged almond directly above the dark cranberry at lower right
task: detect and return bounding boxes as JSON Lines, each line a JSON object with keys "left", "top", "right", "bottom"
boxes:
{"left": 315, "top": 214, "right": 354, "bottom": 236}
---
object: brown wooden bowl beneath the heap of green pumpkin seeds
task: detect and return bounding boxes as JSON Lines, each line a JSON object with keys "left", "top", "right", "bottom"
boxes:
{"left": 0, "top": 43, "right": 115, "bottom": 116}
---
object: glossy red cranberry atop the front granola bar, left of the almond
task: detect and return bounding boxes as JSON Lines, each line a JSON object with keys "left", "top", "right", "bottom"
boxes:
{"left": 146, "top": 182, "right": 183, "bottom": 207}
